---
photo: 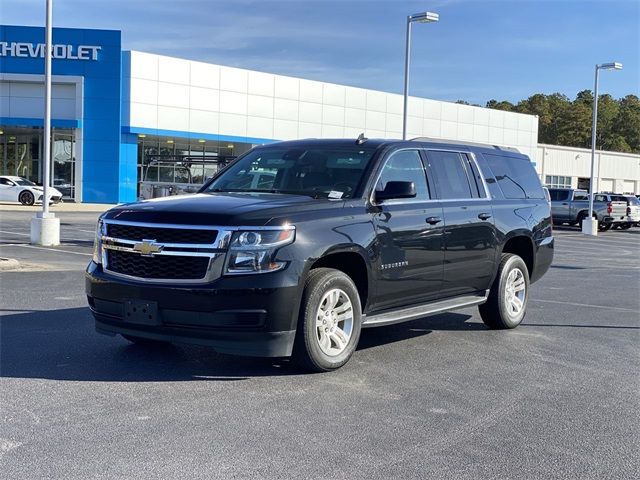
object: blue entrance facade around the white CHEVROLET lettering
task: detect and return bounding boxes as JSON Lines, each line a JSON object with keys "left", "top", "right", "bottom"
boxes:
{"left": 0, "top": 25, "right": 122, "bottom": 203}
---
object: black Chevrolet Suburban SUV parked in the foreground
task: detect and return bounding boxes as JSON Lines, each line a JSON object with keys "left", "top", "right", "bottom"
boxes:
{"left": 86, "top": 138, "right": 553, "bottom": 371}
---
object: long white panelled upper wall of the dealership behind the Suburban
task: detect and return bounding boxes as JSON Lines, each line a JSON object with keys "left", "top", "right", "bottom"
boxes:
{"left": 123, "top": 51, "right": 538, "bottom": 156}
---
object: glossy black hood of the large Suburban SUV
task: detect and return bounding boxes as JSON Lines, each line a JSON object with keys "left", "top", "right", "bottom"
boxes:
{"left": 103, "top": 193, "right": 343, "bottom": 226}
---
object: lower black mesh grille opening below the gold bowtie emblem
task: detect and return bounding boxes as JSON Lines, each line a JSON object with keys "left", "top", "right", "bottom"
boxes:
{"left": 106, "top": 250, "right": 209, "bottom": 280}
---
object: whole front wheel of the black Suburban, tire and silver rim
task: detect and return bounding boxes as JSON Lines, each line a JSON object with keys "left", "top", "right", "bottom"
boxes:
{"left": 293, "top": 268, "right": 362, "bottom": 372}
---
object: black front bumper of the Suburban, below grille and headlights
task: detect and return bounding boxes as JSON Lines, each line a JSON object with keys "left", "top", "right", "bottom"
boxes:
{"left": 85, "top": 262, "right": 301, "bottom": 357}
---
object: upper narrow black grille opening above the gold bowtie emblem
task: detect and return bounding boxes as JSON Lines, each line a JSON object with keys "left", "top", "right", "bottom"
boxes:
{"left": 107, "top": 223, "right": 218, "bottom": 244}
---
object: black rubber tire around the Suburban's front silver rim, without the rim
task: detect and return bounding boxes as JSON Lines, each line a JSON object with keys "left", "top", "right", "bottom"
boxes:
{"left": 298, "top": 268, "right": 362, "bottom": 371}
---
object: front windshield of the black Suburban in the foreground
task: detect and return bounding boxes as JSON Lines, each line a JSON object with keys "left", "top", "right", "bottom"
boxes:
{"left": 203, "top": 145, "right": 374, "bottom": 199}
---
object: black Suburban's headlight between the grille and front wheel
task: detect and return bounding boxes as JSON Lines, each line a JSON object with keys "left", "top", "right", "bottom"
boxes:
{"left": 225, "top": 226, "right": 296, "bottom": 275}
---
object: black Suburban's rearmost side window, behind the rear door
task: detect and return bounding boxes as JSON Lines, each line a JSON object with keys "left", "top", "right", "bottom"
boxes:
{"left": 483, "top": 153, "right": 545, "bottom": 199}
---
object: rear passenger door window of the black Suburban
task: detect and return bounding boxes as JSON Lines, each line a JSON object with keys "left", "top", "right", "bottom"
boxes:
{"left": 427, "top": 151, "right": 478, "bottom": 200}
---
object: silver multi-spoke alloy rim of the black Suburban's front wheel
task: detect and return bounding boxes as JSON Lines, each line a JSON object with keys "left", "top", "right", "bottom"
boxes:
{"left": 316, "top": 288, "right": 353, "bottom": 357}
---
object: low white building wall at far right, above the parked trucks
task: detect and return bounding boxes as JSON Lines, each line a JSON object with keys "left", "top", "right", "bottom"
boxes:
{"left": 535, "top": 144, "right": 640, "bottom": 194}
